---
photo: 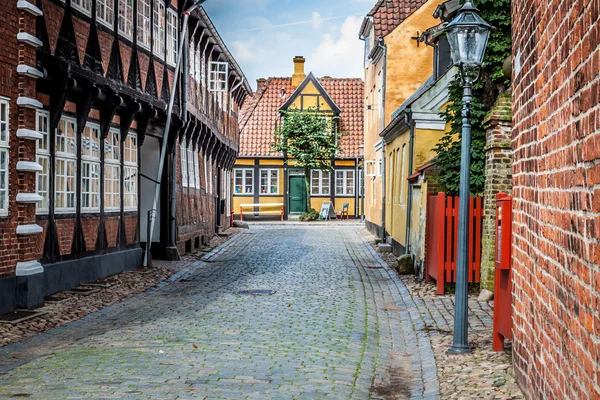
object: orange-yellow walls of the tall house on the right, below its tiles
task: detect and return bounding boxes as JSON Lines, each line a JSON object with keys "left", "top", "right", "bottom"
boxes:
{"left": 364, "top": 0, "right": 444, "bottom": 234}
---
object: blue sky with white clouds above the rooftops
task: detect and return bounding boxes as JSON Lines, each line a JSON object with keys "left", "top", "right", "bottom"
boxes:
{"left": 204, "top": 0, "right": 376, "bottom": 88}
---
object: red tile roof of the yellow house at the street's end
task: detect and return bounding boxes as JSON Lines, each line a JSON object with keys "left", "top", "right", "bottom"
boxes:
{"left": 240, "top": 78, "right": 364, "bottom": 158}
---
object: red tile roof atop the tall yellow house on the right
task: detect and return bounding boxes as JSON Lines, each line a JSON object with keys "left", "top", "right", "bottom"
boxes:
{"left": 367, "top": 0, "right": 427, "bottom": 39}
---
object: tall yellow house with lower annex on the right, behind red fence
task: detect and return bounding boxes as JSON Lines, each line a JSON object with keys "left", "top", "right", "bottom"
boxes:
{"left": 360, "top": 0, "right": 459, "bottom": 255}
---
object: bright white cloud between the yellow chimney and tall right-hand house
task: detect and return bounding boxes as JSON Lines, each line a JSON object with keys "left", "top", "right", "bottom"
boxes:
{"left": 307, "top": 17, "right": 364, "bottom": 78}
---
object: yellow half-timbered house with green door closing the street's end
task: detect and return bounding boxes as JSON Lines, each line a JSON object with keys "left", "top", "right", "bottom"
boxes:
{"left": 233, "top": 57, "right": 364, "bottom": 219}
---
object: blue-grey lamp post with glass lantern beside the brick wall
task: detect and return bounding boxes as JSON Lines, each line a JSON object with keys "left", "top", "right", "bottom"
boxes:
{"left": 445, "top": 0, "right": 491, "bottom": 354}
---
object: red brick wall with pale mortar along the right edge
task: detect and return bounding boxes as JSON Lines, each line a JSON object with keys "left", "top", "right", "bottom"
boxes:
{"left": 512, "top": 0, "right": 600, "bottom": 400}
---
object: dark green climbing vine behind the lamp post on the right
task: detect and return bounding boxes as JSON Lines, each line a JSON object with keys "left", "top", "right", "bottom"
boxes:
{"left": 433, "top": 0, "right": 512, "bottom": 196}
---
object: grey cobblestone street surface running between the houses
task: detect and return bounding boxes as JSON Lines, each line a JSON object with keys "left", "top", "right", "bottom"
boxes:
{"left": 0, "top": 224, "right": 439, "bottom": 400}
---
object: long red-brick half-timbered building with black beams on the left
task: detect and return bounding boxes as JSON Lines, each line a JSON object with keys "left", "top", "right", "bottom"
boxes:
{"left": 0, "top": 0, "right": 251, "bottom": 312}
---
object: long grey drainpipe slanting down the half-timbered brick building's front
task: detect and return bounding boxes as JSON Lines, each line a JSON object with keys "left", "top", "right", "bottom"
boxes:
{"left": 144, "top": 0, "right": 206, "bottom": 267}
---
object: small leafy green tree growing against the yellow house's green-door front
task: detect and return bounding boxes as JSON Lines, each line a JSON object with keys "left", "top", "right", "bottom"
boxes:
{"left": 271, "top": 109, "right": 342, "bottom": 211}
